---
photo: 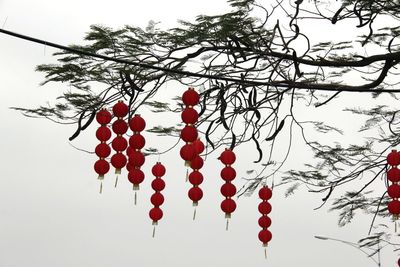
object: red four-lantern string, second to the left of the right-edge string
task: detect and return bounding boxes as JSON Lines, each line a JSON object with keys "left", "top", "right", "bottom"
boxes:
{"left": 219, "top": 148, "right": 236, "bottom": 230}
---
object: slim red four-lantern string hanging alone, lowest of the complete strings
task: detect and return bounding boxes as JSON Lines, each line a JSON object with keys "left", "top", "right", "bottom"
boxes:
{"left": 258, "top": 186, "right": 272, "bottom": 247}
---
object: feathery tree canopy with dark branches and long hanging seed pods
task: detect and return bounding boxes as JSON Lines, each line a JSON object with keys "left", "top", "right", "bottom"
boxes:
{"left": 7, "top": 0, "right": 400, "bottom": 260}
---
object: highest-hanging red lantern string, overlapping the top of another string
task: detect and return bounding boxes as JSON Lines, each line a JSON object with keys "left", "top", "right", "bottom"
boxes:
{"left": 180, "top": 88, "right": 200, "bottom": 169}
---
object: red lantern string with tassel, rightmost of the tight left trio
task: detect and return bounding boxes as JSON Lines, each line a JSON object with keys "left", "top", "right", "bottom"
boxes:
{"left": 127, "top": 114, "right": 146, "bottom": 193}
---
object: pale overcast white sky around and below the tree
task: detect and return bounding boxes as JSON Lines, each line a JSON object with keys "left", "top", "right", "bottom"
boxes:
{"left": 0, "top": 0, "right": 395, "bottom": 267}
